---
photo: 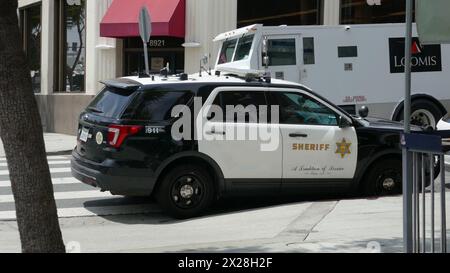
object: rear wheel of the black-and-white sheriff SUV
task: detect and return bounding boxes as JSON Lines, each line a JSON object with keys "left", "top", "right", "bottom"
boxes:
{"left": 156, "top": 165, "right": 214, "bottom": 219}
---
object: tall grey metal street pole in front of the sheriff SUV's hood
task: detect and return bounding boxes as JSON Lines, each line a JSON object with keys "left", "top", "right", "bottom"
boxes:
{"left": 403, "top": 0, "right": 413, "bottom": 253}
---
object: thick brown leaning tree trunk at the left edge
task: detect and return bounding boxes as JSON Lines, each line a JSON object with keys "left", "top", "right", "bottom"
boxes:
{"left": 0, "top": 0, "right": 65, "bottom": 252}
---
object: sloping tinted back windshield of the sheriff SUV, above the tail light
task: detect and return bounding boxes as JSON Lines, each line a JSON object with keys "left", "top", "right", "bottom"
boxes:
{"left": 87, "top": 87, "right": 134, "bottom": 118}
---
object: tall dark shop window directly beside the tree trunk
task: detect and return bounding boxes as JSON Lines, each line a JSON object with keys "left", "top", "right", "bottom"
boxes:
{"left": 20, "top": 4, "right": 42, "bottom": 93}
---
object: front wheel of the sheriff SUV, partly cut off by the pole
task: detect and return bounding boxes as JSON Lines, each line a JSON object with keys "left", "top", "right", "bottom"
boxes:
{"left": 363, "top": 159, "right": 402, "bottom": 196}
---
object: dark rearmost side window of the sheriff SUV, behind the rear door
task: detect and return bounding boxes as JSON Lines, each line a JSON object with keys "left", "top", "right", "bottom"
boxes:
{"left": 135, "top": 91, "right": 194, "bottom": 121}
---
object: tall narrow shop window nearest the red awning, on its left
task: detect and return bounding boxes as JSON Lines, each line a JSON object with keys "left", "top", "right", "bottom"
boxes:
{"left": 54, "top": 0, "right": 86, "bottom": 92}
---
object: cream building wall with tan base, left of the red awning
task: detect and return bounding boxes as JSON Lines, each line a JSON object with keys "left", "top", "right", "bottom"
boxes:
{"left": 19, "top": 0, "right": 121, "bottom": 135}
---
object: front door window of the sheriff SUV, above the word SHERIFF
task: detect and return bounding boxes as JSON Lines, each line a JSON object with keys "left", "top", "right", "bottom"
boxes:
{"left": 271, "top": 92, "right": 338, "bottom": 126}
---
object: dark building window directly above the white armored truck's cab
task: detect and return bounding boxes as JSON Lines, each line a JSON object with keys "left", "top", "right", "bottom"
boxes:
{"left": 237, "top": 0, "right": 322, "bottom": 27}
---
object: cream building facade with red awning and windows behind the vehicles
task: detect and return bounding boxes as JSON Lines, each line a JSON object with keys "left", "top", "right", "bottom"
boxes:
{"left": 19, "top": 0, "right": 412, "bottom": 134}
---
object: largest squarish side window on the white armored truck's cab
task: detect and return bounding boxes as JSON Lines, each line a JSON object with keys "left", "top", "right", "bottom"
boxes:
{"left": 267, "top": 38, "right": 297, "bottom": 66}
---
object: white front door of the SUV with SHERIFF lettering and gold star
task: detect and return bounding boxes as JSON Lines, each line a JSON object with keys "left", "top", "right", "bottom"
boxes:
{"left": 269, "top": 89, "right": 358, "bottom": 183}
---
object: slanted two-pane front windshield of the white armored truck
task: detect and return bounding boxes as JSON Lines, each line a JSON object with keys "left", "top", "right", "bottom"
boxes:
{"left": 219, "top": 34, "right": 255, "bottom": 64}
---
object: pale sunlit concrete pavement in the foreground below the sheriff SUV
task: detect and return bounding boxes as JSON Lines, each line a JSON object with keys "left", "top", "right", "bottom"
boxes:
{"left": 0, "top": 187, "right": 450, "bottom": 253}
